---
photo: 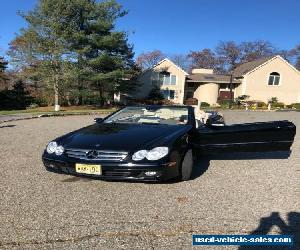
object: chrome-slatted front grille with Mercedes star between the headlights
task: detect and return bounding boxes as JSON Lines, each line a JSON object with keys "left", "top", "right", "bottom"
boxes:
{"left": 66, "top": 149, "right": 128, "bottom": 162}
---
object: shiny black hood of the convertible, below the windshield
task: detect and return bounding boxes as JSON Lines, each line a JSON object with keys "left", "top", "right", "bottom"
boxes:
{"left": 58, "top": 123, "right": 190, "bottom": 152}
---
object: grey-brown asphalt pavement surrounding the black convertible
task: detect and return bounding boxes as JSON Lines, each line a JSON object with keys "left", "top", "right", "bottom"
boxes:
{"left": 0, "top": 111, "right": 300, "bottom": 249}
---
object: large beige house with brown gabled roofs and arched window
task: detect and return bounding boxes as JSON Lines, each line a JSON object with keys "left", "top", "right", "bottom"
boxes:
{"left": 133, "top": 56, "right": 300, "bottom": 105}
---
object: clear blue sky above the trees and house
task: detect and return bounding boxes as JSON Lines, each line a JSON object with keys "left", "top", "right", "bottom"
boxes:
{"left": 0, "top": 0, "right": 300, "bottom": 55}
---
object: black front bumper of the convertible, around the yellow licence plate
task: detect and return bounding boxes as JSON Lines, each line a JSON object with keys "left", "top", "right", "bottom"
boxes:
{"left": 42, "top": 156, "right": 179, "bottom": 181}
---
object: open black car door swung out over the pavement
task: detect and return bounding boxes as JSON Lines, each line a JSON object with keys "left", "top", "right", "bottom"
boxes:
{"left": 191, "top": 121, "right": 296, "bottom": 154}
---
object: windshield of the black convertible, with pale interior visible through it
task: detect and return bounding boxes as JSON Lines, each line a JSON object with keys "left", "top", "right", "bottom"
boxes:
{"left": 104, "top": 107, "right": 188, "bottom": 125}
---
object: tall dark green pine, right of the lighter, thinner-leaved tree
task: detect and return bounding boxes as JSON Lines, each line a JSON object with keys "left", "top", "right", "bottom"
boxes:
{"left": 68, "top": 0, "right": 139, "bottom": 104}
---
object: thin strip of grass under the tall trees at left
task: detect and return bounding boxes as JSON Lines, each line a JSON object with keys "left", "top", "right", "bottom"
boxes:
{"left": 0, "top": 106, "right": 116, "bottom": 115}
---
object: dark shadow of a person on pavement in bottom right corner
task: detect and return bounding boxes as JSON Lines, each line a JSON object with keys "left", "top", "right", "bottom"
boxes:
{"left": 239, "top": 212, "right": 300, "bottom": 250}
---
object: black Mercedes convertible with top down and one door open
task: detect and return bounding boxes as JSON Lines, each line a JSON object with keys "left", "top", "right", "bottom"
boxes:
{"left": 42, "top": 106, "right": 296, "bottom": 181}
